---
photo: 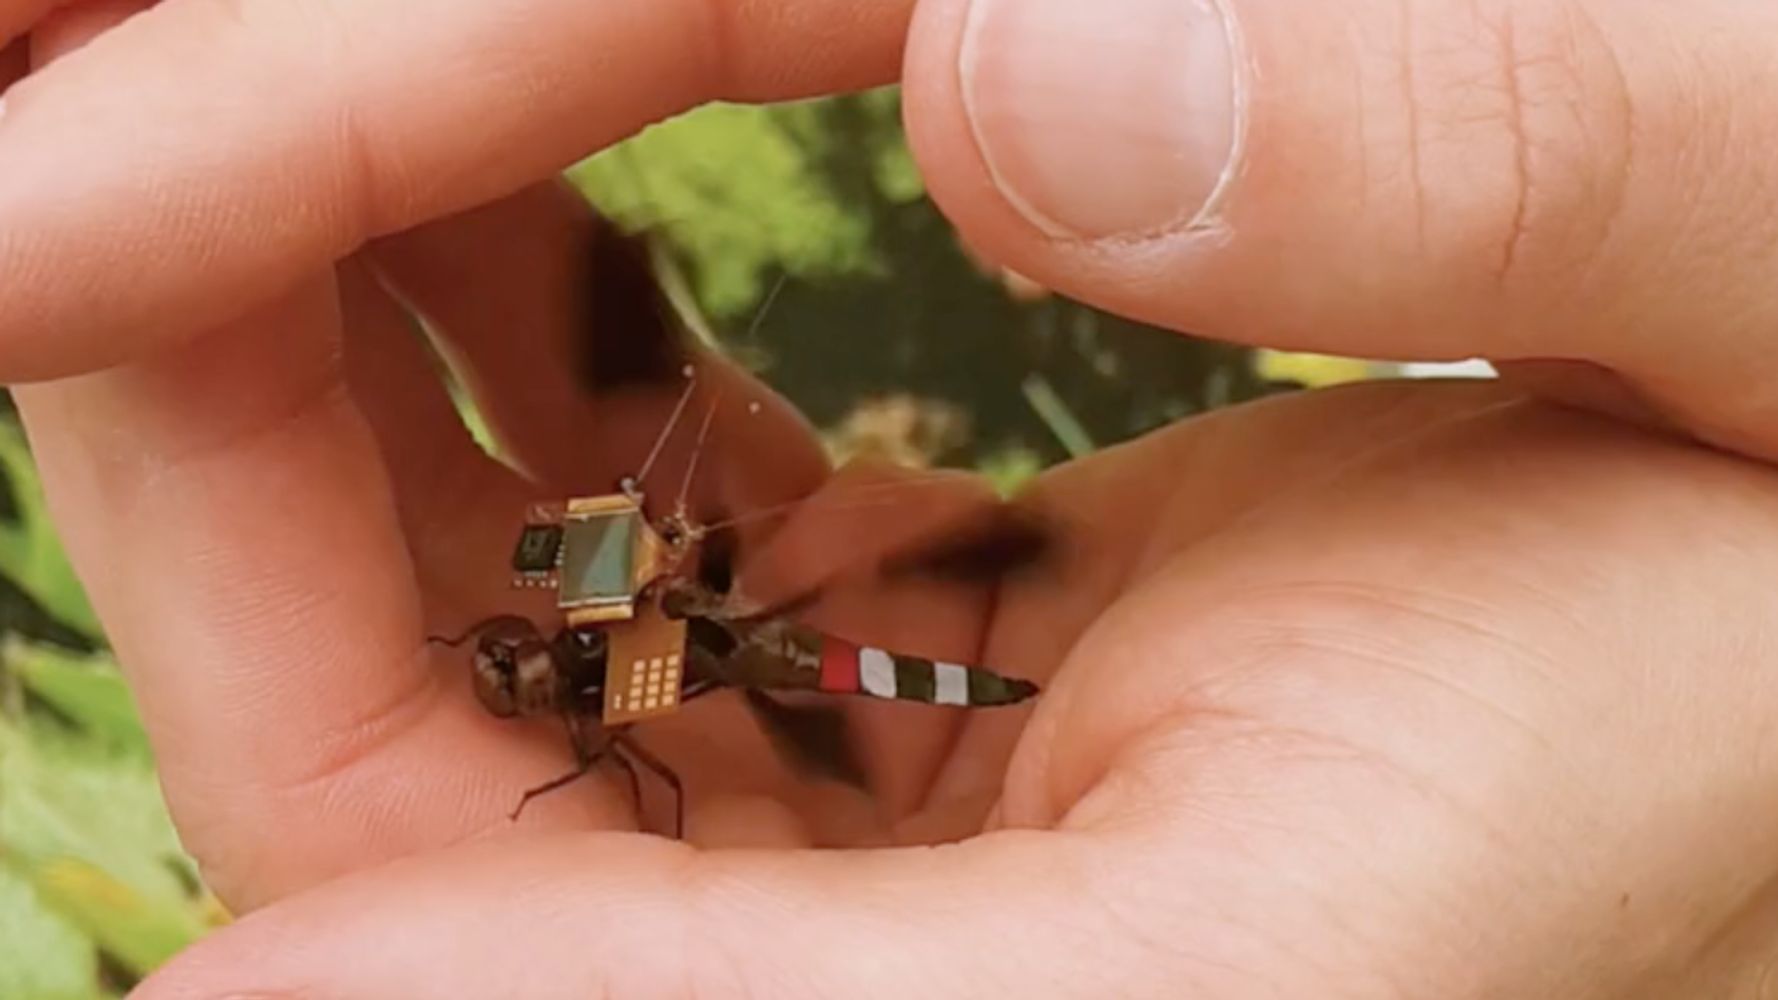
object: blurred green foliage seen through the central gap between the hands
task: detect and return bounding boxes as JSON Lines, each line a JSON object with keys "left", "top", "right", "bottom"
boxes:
{"left": 571, "top": 89, "right": 1271, "bottom": 473}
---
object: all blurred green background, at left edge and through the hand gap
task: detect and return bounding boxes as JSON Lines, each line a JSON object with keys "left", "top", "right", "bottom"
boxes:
{"left": 0, "top": 89, "right": 1486, "bottom": 1000}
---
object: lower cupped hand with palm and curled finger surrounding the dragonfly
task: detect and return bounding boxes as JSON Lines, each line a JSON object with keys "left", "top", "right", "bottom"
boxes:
{"left": 27, "top": 225, "right": 1778, "bottom": 998}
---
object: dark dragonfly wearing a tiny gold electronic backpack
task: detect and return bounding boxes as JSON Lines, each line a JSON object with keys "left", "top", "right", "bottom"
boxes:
{"left": 432, "top": 222, "right": 1053, "bottom": 838}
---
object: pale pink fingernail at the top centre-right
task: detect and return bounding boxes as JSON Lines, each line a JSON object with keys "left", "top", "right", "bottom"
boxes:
{"left": 962, "top": 0, "right": 1245, "bottom": 238}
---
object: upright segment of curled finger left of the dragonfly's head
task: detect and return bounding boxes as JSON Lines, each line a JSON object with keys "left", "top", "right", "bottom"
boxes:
{"left": 18, "top": 274, "right": 476, "bottom": 888}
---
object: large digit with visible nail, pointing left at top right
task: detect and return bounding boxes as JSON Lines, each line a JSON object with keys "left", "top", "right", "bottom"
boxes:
{"left": 907, "top": 0, "right": 1778, "bottom": 457}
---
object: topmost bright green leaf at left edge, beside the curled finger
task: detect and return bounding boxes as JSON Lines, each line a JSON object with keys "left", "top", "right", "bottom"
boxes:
{"left": 0, "top": 418, "right": 101, "bottom": 639}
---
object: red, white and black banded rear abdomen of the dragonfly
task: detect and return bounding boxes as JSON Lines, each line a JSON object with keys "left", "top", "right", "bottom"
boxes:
{"left": 818, "top": 635, "right": 1037, "bottom": 708}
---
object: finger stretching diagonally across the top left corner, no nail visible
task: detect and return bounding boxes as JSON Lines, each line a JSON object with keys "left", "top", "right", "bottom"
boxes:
{"left": 0, "top": 0, "right": 910, "bottom": 381}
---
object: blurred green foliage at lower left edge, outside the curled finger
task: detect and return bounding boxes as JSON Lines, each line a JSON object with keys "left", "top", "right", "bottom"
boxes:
{"left": 0, "top": 469, "right": 217, "bottom": 1000}
